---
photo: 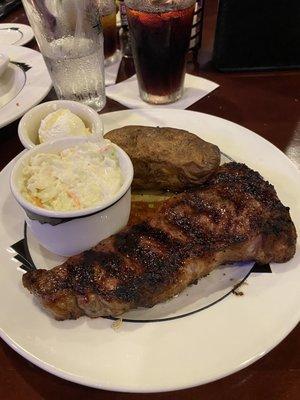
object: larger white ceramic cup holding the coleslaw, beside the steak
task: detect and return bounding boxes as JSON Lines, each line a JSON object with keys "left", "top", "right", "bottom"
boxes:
{"left": 10, "top": 138, "right": 133, "bottom": 256}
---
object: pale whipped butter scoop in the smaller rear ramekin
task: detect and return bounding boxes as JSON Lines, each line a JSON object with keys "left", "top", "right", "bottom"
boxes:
{"left": 38, "top": 108, "right": 91, "bottom": 143}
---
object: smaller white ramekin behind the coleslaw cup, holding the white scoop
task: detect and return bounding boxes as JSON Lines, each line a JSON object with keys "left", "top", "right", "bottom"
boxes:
{"left": 18, "top": 100, "right": 103, "bottom": 149}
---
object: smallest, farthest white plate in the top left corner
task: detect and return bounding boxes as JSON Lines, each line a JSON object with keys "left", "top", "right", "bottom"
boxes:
{"left": 0, "top": 23, "right": 34, "bottom": 46}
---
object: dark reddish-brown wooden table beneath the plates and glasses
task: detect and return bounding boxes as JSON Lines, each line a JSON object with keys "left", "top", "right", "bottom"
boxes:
{"left": 0, "top": 0, "right": 300, "bottom": 400}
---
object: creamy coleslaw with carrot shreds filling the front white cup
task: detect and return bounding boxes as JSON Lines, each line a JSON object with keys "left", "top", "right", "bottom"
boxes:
{"left": 20, "top": 139, "right": 124, "bottom": 211}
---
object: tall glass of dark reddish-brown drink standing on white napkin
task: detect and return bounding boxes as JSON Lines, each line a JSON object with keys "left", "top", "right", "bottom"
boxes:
{"left": 125, "top": 0, "right": 195, "bottom": 104}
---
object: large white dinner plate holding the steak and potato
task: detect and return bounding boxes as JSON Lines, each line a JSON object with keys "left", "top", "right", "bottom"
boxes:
{"left": 0, "top": 109, "right": 300, "bottom": 392}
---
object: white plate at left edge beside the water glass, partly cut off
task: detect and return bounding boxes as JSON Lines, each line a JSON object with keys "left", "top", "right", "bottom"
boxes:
{"left": 0, "top": 44, "right": 52, "bottom": 128}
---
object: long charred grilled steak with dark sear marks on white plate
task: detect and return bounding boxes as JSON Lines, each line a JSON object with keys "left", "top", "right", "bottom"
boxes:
{"left": 23, "top": 163, "right": 296, "bottom": 320}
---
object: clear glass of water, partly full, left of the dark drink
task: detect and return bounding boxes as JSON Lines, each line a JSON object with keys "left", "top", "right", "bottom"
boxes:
{"left": 22, "top": 0, "right": 106, "bottom": 111}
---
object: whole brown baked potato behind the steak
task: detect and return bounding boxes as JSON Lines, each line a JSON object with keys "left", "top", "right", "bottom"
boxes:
{"left": 105, "top": 125, "right": 220, "bottom": 192}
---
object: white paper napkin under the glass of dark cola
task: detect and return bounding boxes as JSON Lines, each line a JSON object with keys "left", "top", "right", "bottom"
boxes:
{"left": 106, "top": 74, "right": 219, "bottom": 110}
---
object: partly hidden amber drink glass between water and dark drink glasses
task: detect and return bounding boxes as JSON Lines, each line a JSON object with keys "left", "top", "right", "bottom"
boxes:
{"left": 98, "top": 0, "right": 118, "bottom": 65}
